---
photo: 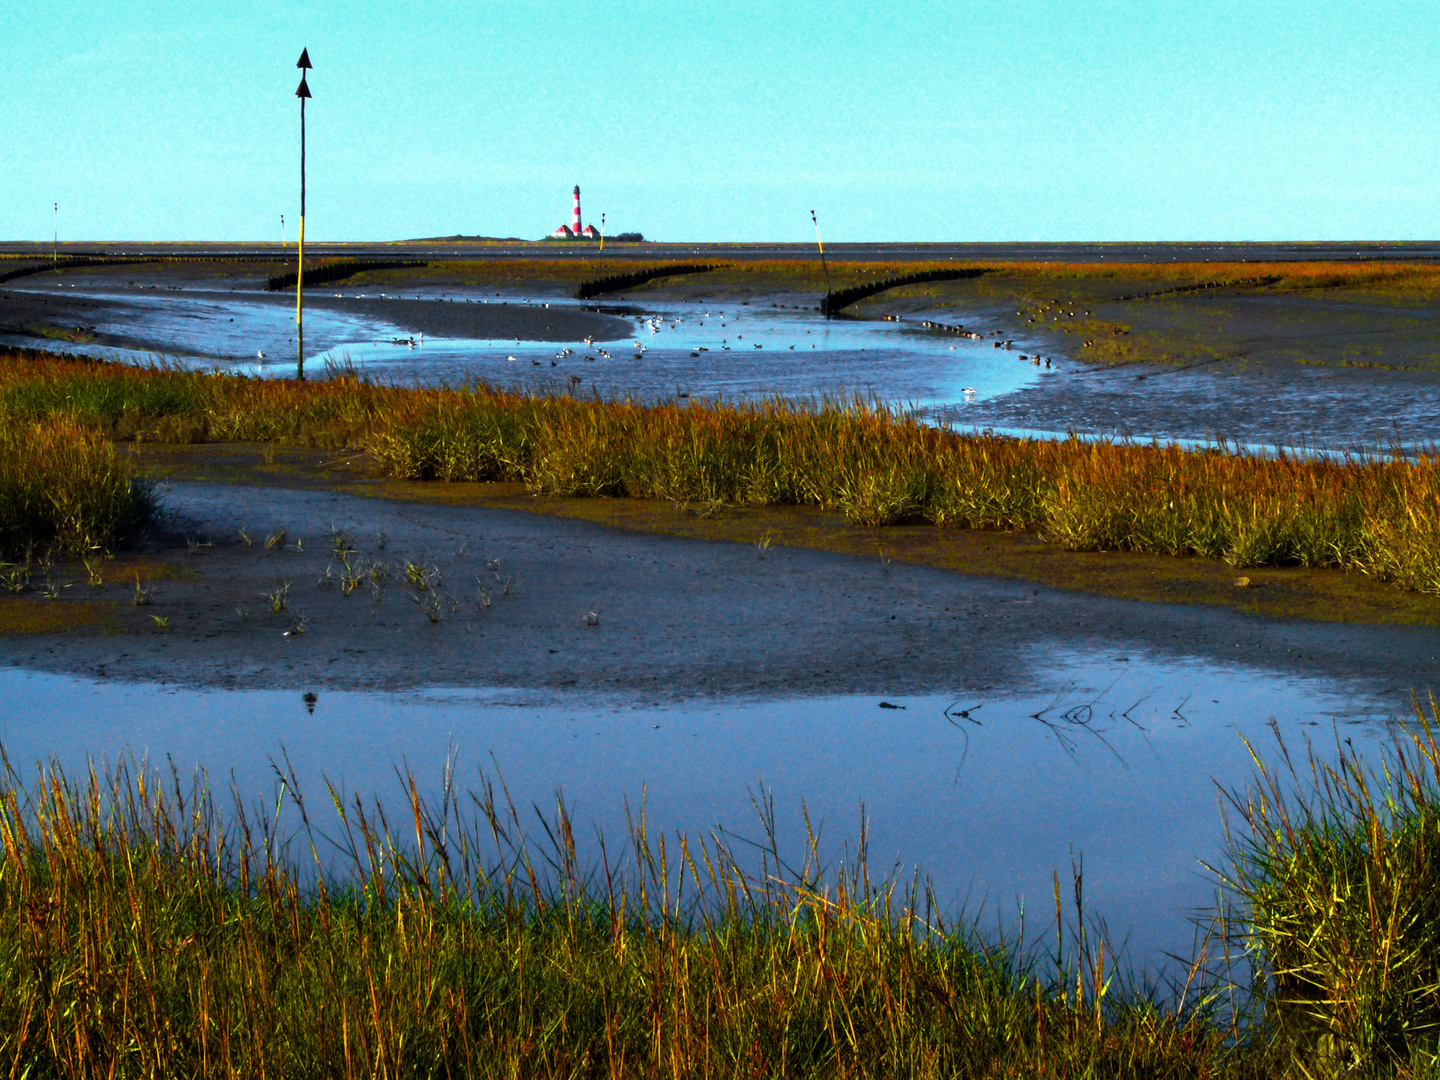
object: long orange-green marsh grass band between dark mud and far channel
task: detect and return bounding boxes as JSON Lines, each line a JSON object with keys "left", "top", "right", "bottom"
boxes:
{"left": 8, "top": 353, "right": 1440, "bottom": 593}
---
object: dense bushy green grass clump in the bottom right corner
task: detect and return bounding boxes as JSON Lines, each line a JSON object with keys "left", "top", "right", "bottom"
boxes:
{"left": 1225, "top": 698, "right": 1440, "bottom": 1074}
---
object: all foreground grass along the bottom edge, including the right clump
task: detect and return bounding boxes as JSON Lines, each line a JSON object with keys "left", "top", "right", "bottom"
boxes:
{"left": 0, "top": 714, "right": 1440, "bottom": 1077}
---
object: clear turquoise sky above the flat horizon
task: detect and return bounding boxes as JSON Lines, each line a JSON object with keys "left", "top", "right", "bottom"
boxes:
{"left": 0, "top": 0, "right": 1440, "bottom": 240}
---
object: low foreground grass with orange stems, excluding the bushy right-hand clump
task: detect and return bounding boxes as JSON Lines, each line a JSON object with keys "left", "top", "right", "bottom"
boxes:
{"left": 0, "top": 766, "right": 1270, "bottom": 1077}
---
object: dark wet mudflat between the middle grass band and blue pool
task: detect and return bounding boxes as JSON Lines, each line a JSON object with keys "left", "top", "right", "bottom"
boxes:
{"left": 0, "top": 482, "right": 1440, "bottom": 713}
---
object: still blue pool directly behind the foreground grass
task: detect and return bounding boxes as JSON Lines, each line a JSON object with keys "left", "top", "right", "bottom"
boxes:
{"left": 0, "top": 652, "right": 1394, "bottom": 963}
